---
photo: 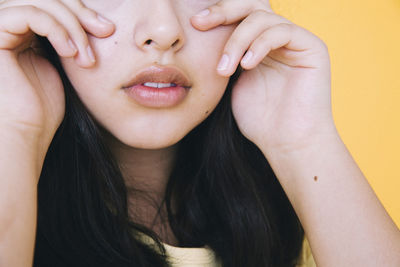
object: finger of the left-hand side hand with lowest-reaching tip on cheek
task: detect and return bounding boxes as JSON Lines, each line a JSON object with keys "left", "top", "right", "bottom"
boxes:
{"left": 2, "top": 0, "right": 96, "bottom": 68}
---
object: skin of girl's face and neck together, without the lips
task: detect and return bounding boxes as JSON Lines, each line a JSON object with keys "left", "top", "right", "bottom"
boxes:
{"left": 58, "top": 0, "right": 235, "bottom": 245}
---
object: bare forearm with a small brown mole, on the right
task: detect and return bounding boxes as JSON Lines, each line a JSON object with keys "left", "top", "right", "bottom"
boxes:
{"left": 262, "top": 134, "right": 400, "bottom": 267}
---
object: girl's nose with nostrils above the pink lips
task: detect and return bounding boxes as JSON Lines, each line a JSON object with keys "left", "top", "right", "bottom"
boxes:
{"left": 135, "top": 0, "right": 185, "bottom": 51}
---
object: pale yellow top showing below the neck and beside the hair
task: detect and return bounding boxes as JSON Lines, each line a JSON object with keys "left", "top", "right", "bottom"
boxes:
{"left": 140, "top": 234, "right": 316, "bottom": 267}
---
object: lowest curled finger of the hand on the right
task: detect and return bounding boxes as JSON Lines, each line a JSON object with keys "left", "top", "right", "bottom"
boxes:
{"left": 241, "top": 23, "right": 323, "bottom": 69}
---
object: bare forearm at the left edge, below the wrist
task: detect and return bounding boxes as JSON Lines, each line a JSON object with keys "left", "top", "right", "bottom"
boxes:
{"left": 0, "top": 132, "right": 40, "bottom": 267}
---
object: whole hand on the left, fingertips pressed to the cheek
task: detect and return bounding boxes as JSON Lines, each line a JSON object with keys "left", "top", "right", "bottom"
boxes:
{"left": 0, "top": 0, "right": 114, "bottom": 151}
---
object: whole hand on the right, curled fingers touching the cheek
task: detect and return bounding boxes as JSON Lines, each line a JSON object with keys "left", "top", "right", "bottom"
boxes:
{"left": 191, "top": 0, "right": 336, "bottom": 151}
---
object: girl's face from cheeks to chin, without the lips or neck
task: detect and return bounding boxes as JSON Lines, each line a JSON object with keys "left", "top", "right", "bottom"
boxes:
{"left": 61, "top": 0, "right": 235, "bottom": 149}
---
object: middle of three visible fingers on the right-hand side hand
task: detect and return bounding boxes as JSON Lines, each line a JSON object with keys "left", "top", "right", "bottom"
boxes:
{"left": 218, "top": 10, "right": 291, "bottom": 76}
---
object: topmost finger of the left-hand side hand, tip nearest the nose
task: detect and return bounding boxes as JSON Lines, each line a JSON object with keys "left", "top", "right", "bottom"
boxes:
{"left": 61, "top": 0, "right": 115, "bottom": 37}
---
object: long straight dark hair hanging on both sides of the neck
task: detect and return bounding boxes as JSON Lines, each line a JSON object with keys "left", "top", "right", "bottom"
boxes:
{"left": 34, "top": 38, "right": 304, "bottom": 267}
